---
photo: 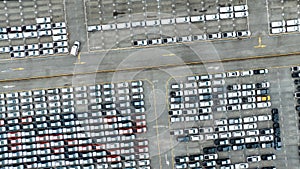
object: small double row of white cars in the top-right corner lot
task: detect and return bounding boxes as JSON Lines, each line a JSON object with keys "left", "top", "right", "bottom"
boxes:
{"left": 270, "top": 19, "right": 300, "bottom": 34}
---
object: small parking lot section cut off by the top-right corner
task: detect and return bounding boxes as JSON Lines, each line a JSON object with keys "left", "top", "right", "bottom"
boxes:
{"left": 267, "top": 0, "right": 300, "bottom": 35}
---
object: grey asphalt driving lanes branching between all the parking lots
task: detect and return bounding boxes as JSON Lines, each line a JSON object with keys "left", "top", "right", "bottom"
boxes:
{"left": 0, "top": 0, "right": 300, "bottom": 169}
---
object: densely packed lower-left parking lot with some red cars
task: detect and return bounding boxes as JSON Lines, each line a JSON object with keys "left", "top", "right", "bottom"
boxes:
{"left": 0, "top": 81, "right": 152, "bottom": 169}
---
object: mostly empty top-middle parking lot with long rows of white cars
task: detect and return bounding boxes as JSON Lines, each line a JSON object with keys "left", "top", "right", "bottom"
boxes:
{"left": 86, "top": 0, "right": 251, "bottom": 50}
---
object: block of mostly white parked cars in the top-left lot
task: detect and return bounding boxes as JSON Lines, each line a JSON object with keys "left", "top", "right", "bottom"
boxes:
{"left": 0, "top": 17, "right": 69, "bottom": 58}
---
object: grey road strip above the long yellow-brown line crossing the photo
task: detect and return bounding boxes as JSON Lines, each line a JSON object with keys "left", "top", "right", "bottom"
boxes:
{"left": 0, "top": 35, "right": 300, "bottom": 82}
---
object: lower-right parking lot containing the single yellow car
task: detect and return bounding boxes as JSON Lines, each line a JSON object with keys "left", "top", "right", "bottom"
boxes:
{"left": 168, "top": 67, "right": 299, "bottom": 168}
